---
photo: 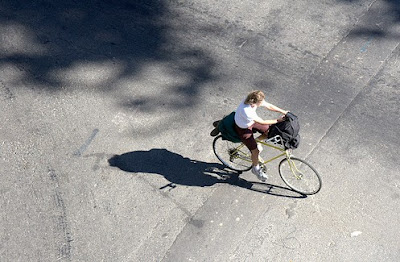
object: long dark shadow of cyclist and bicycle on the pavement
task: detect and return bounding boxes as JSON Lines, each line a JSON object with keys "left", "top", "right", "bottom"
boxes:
{"left": 108, "top": 149, "right": 306, "bottom": 198}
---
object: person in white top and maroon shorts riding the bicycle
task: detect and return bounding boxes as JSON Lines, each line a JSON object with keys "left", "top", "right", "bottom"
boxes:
{"left": 235, "top": 90, "right": 289, "bottom": 181}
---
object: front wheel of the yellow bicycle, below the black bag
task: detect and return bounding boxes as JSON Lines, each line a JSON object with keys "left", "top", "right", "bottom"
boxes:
{"left": 279, "top": 157, "right": 322, "bottom": 195}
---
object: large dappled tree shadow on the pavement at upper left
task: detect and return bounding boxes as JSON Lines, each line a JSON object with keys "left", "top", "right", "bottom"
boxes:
{"left": 0, "top": 0, "right": 214, "bottom": 111}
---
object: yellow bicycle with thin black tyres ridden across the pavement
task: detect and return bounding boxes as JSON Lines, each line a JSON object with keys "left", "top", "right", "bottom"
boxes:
{"left": 213, "top": 135, "right": 322, "bottom": 195}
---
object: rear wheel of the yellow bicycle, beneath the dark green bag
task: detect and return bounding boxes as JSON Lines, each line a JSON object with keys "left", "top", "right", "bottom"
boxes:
{"left": 213, "top": 135, "right": 252, "bottom": 171}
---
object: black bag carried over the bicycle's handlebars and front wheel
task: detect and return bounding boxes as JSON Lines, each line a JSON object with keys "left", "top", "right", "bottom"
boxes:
{"left": 268, "top": 112, "right": 300, "bottom": 149}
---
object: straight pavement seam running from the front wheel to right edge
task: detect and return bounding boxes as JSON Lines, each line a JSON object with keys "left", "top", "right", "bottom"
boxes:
{"left": 304, "top": 42, "right": 400, "bottom": 159}
